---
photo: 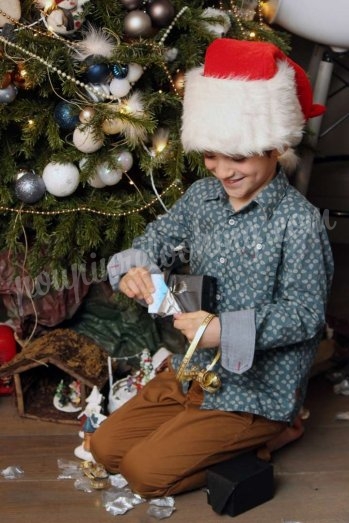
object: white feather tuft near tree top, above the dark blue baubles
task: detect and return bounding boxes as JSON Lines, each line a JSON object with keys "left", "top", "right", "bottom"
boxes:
{"left": 75, "top": 25, "right": 116, "bottom": 62}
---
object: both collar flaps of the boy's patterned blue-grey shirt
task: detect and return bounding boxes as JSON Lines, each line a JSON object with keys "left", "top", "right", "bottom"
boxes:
{"left": 203, "top": 169, "right": 289, "bottom": 218}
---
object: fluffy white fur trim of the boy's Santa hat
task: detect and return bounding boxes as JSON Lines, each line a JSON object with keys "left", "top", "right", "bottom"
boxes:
{"left": 182, "top": 60, "right": 305, "bottom": 156}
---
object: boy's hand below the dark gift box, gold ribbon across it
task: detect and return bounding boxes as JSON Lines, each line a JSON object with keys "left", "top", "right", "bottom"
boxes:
{"left": 173, "top": 311, "right": 221, "bottom": 349}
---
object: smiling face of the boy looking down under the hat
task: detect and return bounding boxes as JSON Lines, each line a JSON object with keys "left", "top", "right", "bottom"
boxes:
{"left": 204, "top": 150, "right": 278, "bottom": 211}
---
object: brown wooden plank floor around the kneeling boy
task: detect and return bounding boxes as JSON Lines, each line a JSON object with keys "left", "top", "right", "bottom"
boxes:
{"left": 0, "top": 368, "right": 349, "bottom": 523}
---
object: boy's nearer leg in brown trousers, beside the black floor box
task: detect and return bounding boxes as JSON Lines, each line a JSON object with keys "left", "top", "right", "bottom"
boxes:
{"left": 120, "top": 384, "right": 286, "bottom": 497}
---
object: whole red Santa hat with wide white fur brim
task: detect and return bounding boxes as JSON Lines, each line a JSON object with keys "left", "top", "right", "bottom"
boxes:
{"left": 182, "top": 38, "right": 325, "bottom": 170}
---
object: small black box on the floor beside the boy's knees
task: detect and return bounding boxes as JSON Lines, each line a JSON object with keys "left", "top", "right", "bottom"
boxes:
{"left": 207, "top": 453, "right": 274, "bottom": 516}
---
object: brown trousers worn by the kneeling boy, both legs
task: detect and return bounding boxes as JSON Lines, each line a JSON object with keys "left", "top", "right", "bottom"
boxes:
{"left": 91, "top": 370, "right": 286, "bottom": 498}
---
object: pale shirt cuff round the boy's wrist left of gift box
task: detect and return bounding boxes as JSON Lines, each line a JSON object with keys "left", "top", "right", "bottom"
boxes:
{"left": 107, "top": 248, "right": 161, "bottom": 291}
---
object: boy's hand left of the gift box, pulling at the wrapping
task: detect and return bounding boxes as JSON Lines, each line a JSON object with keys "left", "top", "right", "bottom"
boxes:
{"left": 119, "top": 267, "right": 155, "bottom": 305}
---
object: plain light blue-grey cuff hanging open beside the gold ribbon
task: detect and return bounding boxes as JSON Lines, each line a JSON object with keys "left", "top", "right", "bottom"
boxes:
{"left": 220, "top": 309, "right": 256, "bottom": 374}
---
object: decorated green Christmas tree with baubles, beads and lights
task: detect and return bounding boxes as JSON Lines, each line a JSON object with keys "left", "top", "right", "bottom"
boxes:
{"left": 0, "top": 0, "right": 288, "bottom": 283}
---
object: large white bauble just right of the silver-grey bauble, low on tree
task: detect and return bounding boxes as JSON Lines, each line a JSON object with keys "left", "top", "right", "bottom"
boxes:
{"left": 42, "top": 162, "right": 80, "bottom": 197}
